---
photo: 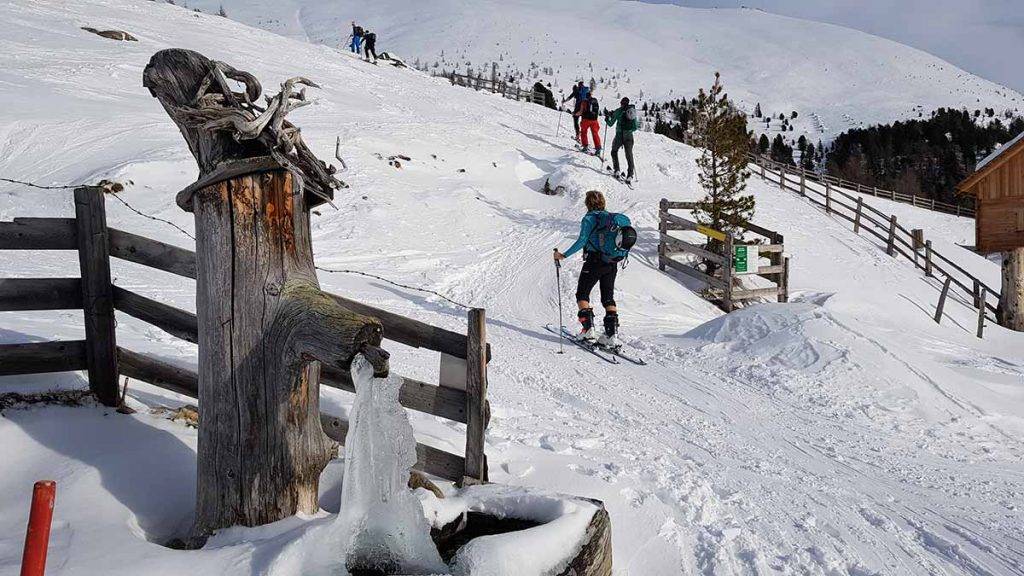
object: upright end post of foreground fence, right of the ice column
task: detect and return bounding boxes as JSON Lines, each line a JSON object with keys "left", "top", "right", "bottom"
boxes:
{"left": 463, "top": 308, "right": 487, "bottom": 484}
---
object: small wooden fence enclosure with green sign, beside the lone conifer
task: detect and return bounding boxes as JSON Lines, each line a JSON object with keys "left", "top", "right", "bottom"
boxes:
{"left": 657, "top": 199, "right": 790, "bottom": 312}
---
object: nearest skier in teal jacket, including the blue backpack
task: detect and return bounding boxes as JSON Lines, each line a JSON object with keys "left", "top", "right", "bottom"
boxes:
{"left": 554, "top": 190, "right": 637, "bottom": 352}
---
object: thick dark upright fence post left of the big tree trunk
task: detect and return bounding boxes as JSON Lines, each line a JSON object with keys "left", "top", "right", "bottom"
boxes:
{"left": 75, "top": 187, "right": 120, "bottom": 406}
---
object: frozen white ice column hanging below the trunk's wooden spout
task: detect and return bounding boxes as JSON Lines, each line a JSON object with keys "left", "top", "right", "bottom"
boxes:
{"left": 337, "top": 356, "right": 447, "bottom": 574}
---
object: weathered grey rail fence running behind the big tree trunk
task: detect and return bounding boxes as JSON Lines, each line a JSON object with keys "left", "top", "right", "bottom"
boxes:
{"left": 0, "top": 188, "right": 490, "bottom": 482}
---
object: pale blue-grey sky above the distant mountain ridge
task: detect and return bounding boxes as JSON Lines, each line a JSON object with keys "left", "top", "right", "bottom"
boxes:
{"left": 640, "top": 0, "right": 1024, "bottom": 92}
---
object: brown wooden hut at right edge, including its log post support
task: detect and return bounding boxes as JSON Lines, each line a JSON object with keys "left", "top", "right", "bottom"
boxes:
{"left": 957, "top": 132, "right": 1024, "bottom": 332}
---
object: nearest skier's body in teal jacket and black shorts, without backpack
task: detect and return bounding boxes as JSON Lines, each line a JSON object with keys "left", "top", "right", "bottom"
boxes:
{"left": 554, "top": 190, "right": 618, "bottom": 347}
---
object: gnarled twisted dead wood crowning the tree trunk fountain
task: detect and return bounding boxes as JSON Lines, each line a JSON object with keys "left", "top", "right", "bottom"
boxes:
{"left": 142, "top": 48, "right": 346, "bottom": 210}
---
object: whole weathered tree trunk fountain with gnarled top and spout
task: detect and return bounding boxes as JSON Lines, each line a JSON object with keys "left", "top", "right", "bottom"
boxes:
{"left": 144, "top": 50, "right": 388, "bottom": 538}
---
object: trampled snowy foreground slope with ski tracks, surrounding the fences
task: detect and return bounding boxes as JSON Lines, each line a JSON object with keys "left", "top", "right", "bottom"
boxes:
{"left": 0, "top": 0, "right": 1024, "bottom": 576}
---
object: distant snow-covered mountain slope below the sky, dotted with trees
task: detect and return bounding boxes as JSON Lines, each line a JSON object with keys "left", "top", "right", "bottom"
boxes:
{"left": 188, "top": 0, "right": 1024, "bottom": 142}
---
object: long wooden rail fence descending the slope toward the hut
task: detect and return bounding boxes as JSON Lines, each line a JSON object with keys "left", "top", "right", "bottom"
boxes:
{"left": 756, "top": 157, "right": 999, "bottom": 338}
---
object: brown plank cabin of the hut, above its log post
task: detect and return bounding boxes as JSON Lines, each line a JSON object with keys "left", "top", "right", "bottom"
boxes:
{"left": 956, "top": 132, "right": 1024, "bottom": 253}
